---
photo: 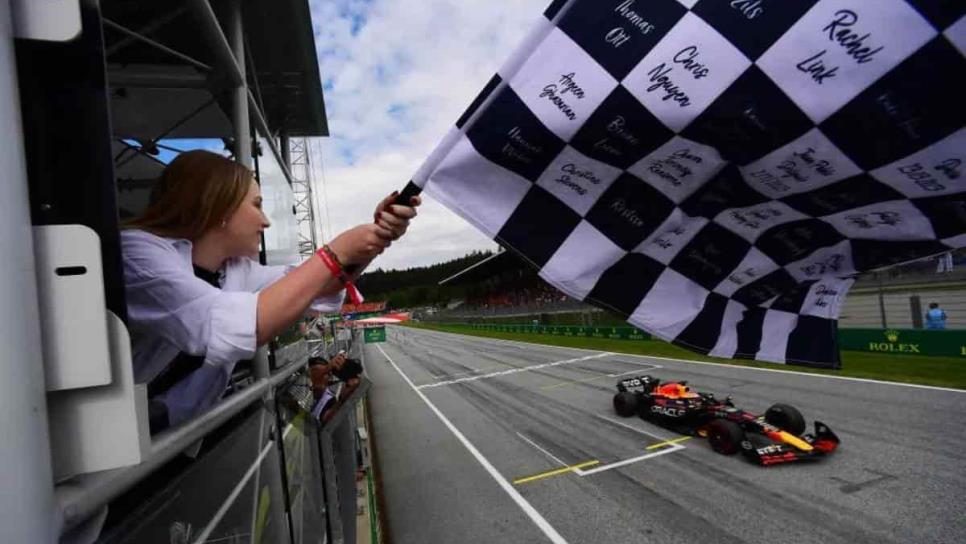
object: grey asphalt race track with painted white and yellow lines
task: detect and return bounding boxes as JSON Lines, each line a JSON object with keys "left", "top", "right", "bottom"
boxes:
{"left": 364, "top": 327, "right": 966, "bottom": 544}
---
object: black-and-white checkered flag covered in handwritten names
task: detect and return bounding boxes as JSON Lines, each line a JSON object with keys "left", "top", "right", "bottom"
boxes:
{"left": 414, "top": 0, "right": 966, "bottom": 367}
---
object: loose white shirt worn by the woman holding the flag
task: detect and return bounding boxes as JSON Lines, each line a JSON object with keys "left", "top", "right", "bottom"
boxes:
{"left": 121, "top": 229, "right": 345, "bottom": 425}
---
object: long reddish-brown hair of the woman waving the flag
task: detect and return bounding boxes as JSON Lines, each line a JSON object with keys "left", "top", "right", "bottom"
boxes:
{"left": 124, "top": 150, "right": 255, "bottom": 240}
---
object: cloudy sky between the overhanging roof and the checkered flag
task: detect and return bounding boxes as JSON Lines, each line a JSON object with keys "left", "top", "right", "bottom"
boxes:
{"left": 309, "top": 0, "right": 550, "bottom": 269}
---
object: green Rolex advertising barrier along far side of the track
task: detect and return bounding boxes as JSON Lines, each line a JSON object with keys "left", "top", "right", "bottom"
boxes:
{"left": 447, "top": 323, "right": 966, "bottom": 359}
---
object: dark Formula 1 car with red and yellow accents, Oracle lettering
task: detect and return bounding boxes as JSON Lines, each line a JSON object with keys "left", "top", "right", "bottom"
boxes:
{"left": 614, "top": 376, "right": 839, "bottom": 466}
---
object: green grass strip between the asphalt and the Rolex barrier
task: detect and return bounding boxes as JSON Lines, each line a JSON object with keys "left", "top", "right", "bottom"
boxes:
{"left": 406, "top": 323, "right": 966, "bottom": 389}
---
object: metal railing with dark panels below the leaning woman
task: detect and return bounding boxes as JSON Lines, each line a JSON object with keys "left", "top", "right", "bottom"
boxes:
{"left": 55, "top": 331, "right": 370, "bottom": 544}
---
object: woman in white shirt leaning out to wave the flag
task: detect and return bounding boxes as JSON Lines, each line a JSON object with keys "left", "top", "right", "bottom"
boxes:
{"left": 121, "top": 151, "right": 420, "bottom": 432}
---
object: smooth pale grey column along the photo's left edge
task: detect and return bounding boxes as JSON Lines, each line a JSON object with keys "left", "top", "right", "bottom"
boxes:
{"left": 0, "top": 2, "right": 55, "bottom": 544}
